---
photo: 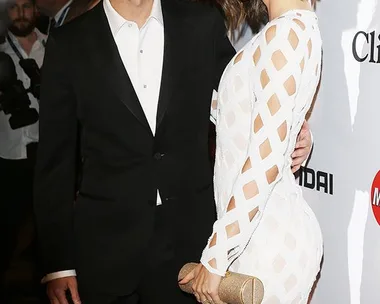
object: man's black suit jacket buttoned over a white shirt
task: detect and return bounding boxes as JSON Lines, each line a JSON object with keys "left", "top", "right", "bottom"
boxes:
{"left": 35, "top": 0, "right": 234, "bottom": 294}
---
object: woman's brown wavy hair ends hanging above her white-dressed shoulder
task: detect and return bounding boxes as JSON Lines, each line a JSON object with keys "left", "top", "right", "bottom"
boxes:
{"left": 218, "top": 0, "right": 268, "bottom": 32}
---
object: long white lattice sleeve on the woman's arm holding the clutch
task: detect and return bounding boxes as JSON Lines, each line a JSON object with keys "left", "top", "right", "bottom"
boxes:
{"left": 201, "top": 18, "right": 312, "bottom": 276}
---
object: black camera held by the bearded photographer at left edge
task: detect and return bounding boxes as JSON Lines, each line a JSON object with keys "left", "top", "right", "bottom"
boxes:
{"left": 0, "top": 52, "right": 39, "bottom": 130}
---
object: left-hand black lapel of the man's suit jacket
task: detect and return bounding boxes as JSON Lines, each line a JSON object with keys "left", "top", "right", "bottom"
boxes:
{"left": 88, "top": 1, "right": 153, "bottom": 135}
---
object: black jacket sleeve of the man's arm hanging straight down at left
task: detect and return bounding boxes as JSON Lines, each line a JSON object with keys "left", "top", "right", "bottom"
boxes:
{"left": 34, "top": 30, "right": 77, "bottom": 273}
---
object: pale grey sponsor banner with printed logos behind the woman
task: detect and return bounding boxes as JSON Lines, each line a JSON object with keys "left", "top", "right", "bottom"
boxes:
{"left": 235, "top": 0, "right": 380, "bottom": 304}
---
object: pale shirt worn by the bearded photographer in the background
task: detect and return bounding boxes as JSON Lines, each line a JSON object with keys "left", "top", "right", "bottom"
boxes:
{"left": 0, "top": 29, "right": 46, "bottom": 159}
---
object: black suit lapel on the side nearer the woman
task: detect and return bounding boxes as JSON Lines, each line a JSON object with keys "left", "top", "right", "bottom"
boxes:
{"left": 156, "top": 0, "right": 186, "bottom": 129}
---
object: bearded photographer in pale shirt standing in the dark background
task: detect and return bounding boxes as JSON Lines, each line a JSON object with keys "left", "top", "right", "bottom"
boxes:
{"left": 0, "top": 0, "right": 46, "bottom": 296}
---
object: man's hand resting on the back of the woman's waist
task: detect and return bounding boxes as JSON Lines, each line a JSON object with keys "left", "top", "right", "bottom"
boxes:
{"left": 292, "top": 121, "right": 312, "bottom": 173}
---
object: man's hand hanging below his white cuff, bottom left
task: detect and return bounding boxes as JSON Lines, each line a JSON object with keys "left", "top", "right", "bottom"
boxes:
{"left": 47, "top": 277, "right": 81, "bottom": 304}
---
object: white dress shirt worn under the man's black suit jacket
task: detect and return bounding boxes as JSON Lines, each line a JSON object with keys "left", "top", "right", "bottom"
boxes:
{"left": 43, "top": 0, "right": 164, "bottom": 282}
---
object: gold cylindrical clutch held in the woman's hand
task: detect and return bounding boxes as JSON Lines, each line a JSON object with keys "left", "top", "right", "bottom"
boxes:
{"left": 178, "top": 263, "right": 264, "bottom": 304}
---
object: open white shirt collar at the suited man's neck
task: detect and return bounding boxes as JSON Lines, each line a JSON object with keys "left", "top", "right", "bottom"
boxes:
{"left": 103, "top": 0, "right": 164, "bottom": 36}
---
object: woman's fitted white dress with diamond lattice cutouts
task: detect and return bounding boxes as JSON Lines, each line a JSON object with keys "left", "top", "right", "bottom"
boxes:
{"left": 201, "top": 10, "right": 323, "bottom": 304}
